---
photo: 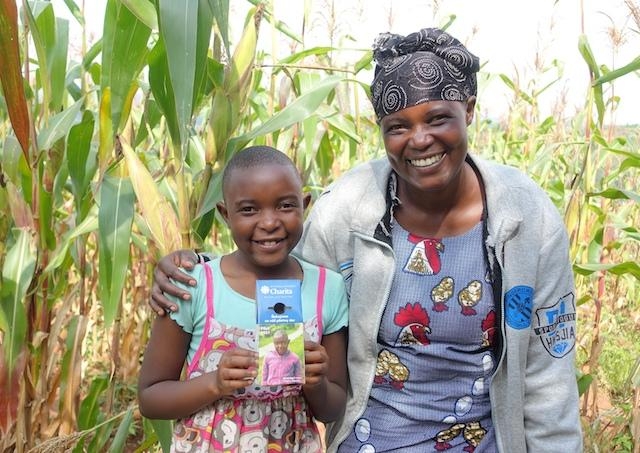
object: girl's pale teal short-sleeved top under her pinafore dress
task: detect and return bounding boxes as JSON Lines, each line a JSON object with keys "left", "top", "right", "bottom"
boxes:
{"left": 169, "top": 257, "right": 349, "bottom": 363}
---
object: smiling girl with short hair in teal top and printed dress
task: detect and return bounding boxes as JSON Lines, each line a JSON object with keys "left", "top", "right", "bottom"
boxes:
{"left": 138, "top": 146, "right": 348, "bottom": 452}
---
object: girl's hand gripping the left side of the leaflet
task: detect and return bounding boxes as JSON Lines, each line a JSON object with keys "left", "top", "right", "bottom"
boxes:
{"left": 212, "top": 348, "right": 258, "bottom": 396}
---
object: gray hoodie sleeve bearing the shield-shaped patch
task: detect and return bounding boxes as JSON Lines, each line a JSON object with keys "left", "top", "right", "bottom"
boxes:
{"left": 524, "top": 222, "right": 582, "bottom": 453}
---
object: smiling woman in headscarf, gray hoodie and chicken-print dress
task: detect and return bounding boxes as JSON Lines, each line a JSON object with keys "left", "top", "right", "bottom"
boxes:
{"left": 152, "top": 28, "right": 582, "bottom": 453}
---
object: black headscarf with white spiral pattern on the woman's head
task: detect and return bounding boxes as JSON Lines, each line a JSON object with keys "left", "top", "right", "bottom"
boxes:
{"left": 371, "top": 28, "right": 480, "bottom": 120}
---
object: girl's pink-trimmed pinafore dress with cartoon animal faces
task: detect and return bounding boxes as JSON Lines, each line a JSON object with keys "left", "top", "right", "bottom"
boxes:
{"left": 171, "top": 264, "right": 326, "bottom": 453}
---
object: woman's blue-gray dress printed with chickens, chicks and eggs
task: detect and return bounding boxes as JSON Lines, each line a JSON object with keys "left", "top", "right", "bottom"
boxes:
{"left": 339, "top": 223, "right": 496, "bottom": 453}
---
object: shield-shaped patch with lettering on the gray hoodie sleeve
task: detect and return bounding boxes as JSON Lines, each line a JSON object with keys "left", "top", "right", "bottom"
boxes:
{"left": 533, "top": 293, "right": 576, "bottom": 359}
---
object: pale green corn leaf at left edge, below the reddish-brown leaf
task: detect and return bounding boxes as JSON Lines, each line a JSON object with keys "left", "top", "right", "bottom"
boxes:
{"left": 0, "top": 228, "right": 36, "bottom": 368}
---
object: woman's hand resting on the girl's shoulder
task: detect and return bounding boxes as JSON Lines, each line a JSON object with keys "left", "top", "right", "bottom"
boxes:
{"left": 149, "top": 250, "right": 198, "bottom": 316}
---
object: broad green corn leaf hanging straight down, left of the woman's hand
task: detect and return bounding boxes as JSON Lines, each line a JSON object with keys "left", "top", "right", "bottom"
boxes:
{"left": 98, "top": 174, "right": 135, "bottom": 326}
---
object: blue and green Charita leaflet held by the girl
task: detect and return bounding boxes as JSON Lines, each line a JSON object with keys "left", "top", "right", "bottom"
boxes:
{"left": 256, "top": 279, "right": 304, "bottom": 386}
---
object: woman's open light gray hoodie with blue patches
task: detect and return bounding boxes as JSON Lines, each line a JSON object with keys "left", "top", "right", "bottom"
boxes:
{"left": 296, "top": 156, "right": 582, "bottom": 453}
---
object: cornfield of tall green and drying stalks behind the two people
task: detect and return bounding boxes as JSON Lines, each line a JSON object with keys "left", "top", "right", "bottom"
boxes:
{"left": 0, "top": 0, "right": 640, "bottom": 453}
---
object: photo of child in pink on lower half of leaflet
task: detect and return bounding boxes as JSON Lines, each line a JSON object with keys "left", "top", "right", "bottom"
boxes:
{"left": 260, "top": 324, "right": 304, "bottom": 385}
